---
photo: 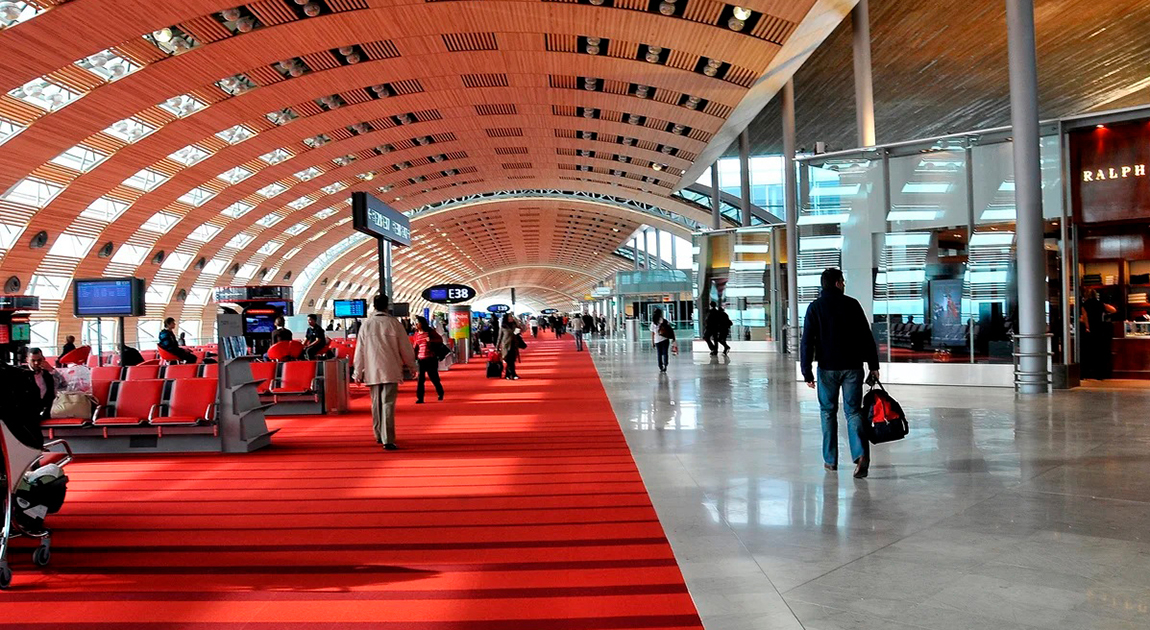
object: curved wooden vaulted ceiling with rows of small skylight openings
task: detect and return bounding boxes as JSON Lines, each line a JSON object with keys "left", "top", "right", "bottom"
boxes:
{"left": 0, "top": 0, "right": 853, "bottom": 335}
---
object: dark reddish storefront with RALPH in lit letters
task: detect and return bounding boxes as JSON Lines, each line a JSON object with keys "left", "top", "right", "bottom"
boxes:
{"left": 1067, "top": 112, "right": 1150, "bottom": 384}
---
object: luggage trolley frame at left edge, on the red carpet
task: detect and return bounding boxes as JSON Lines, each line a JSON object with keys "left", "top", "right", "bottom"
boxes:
{"left": 0, "top": 423, "right": 72, "bottom": 589}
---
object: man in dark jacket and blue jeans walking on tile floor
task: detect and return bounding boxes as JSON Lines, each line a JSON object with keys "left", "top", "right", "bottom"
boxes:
{"left": 802, "top": 269, "right": 879, "bottom": 478}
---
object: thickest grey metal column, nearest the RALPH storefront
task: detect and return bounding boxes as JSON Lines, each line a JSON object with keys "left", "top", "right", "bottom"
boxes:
{"left": 1006, "top": 0, "right": 1050, "bottom": 393}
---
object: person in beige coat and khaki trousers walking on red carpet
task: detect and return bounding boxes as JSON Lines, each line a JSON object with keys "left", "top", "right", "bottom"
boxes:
{"left": 354, "top": 295, "right": 415, "bottom": 451}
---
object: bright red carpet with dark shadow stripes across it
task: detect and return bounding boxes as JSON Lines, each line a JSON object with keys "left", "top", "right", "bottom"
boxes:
{"left": 0, "top": 331, "right": 702, "bottom": 630}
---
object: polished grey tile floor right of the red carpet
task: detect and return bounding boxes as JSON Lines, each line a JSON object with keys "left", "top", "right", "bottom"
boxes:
{"left": 590, "top": 340, "right": 1150, "bottom": 630}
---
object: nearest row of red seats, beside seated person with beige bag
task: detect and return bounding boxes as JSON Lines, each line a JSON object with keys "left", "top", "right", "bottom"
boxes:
{"left": 41, "top": 378, "right": 217, "bottom": 437}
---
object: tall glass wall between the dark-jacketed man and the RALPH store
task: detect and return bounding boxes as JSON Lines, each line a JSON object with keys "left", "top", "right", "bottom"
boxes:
{"left": 798, "top": 125, "right": 1064, "bottom": 363}
